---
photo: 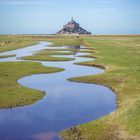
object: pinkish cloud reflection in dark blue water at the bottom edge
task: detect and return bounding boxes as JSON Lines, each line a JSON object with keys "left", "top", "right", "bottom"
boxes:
{"left": 32, "top": 132, "right": 57, "bottom": 140}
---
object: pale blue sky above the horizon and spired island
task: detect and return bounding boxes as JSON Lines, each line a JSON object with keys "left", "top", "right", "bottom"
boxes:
{"left": 0, "top": 0, "right": 140, "bottom": 34}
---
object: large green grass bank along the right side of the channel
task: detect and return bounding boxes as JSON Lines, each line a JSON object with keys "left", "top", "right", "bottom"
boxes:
{"left": 61, "top": 36, "right": 140, "bottom": 140}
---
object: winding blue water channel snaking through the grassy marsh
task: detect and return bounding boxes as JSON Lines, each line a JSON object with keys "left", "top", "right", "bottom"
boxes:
{"left": 0, "top": 42, "right": 116, "bottom": 140}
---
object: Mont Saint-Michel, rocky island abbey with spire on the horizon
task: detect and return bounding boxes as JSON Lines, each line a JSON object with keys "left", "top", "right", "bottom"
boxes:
{"left": 57, "top": 18, "right": 91, "bottom": 34}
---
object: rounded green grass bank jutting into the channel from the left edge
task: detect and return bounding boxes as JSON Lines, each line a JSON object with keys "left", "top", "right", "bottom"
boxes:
{"left": 0, "top": 62, "right": 64, "bottom": 108}
